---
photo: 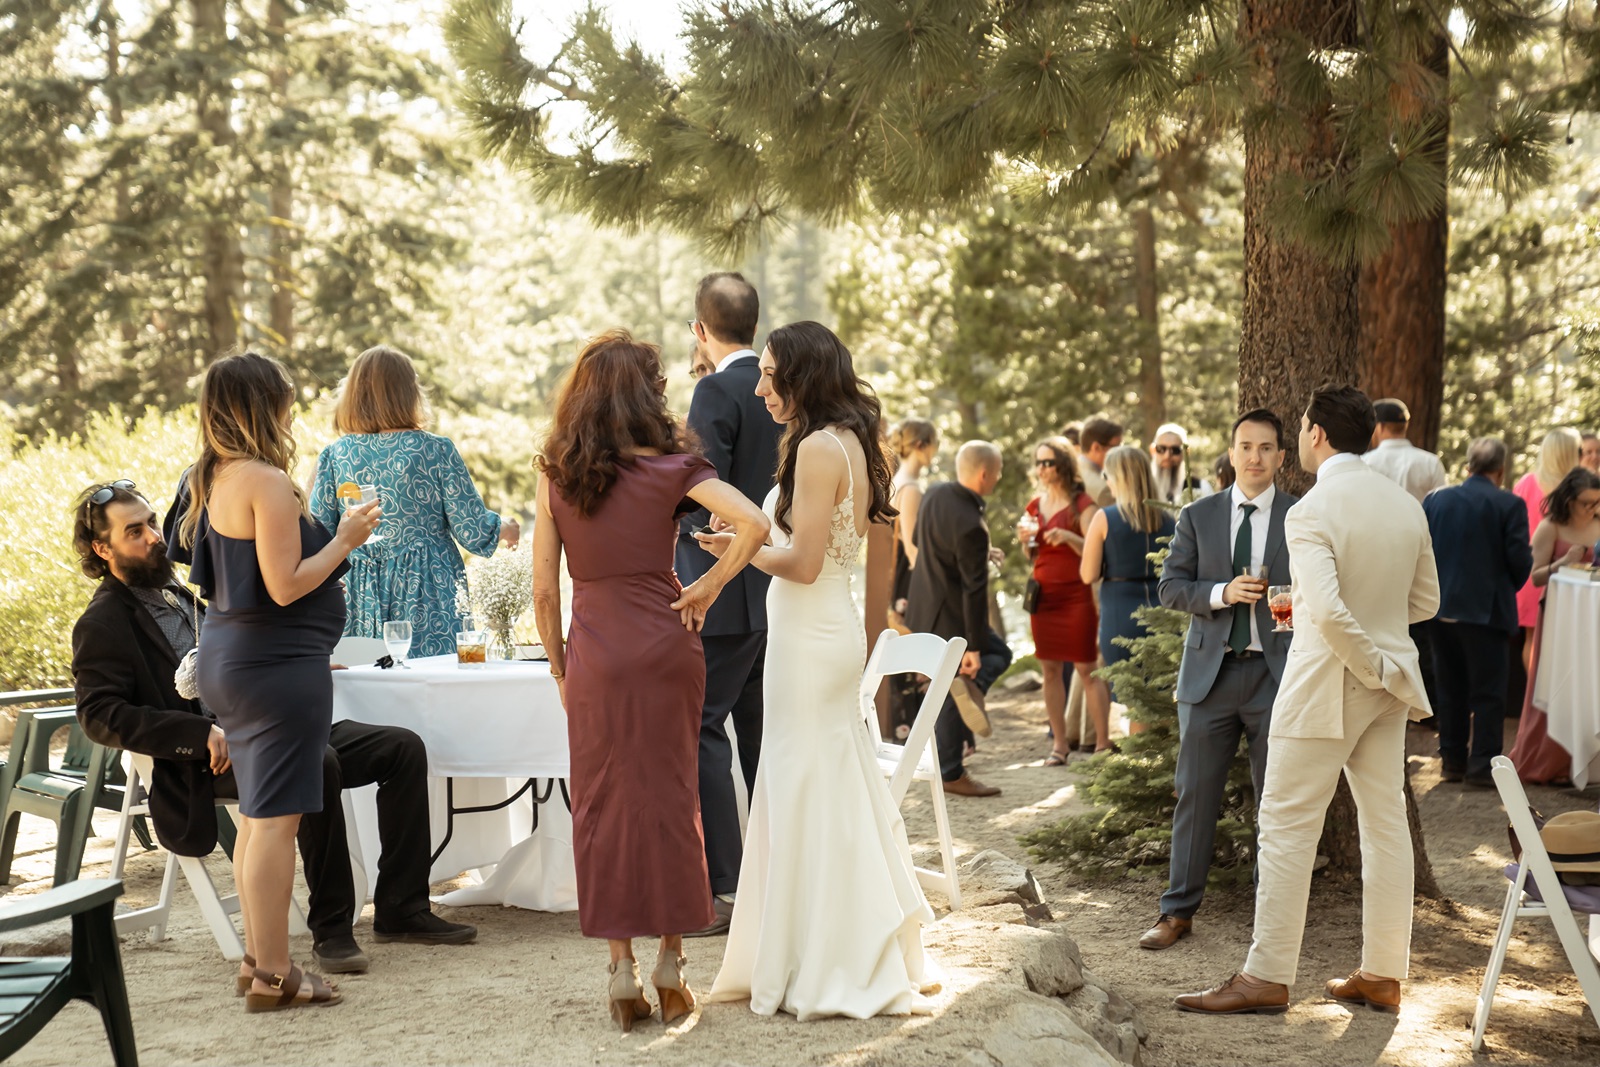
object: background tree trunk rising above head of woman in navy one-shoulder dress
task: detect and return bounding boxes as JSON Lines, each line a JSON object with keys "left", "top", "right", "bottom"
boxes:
{"left": 192, "top": 0, "right": 245, "bottom": 357}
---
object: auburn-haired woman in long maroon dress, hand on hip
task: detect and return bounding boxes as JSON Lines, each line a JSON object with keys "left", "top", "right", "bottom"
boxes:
{"left": 533, "top": 331, "right": 770, "bottom": 1030}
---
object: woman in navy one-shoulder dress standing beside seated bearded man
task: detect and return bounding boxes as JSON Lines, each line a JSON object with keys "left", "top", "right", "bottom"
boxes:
{"left": 178, "top": 352, "right": 382, "bottom": 1011}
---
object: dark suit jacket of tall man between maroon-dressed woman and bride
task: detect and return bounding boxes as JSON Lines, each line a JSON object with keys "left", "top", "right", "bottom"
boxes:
{"left": 677, "top": 354, "right": 781, "bottom": 637}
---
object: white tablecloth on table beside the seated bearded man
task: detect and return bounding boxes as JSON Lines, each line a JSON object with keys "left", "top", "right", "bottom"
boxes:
{"left": 333, "top": 656, "right": 578, "bottom": 912}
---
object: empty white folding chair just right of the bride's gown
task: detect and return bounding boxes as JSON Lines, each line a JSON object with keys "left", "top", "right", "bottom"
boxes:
{"left": 861, "top": 630, "right": 966, "bottom": 912}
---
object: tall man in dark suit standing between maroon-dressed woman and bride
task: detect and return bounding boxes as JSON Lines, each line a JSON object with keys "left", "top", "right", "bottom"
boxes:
{"left": 677, "top": 274, "right": 779, "bottom": 936}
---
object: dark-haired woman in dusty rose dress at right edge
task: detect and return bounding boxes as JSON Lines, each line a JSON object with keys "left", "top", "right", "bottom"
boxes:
{"left": 1510, "top": 467, "right": 1600, "bottom": 784}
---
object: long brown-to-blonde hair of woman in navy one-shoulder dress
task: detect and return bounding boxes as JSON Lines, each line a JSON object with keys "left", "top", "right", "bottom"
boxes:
{"left": 178, "top": 352, "right": 307, "bottom": 547}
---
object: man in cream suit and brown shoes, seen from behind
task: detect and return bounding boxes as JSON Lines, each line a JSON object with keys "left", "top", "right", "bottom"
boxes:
{"left": 1176, "top": 386, "right": 1438, "bottom": 1014}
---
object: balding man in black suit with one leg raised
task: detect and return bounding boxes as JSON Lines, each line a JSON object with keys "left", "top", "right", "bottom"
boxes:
{"left": 906, "top": 442, "right": 1011, "bottom": 797}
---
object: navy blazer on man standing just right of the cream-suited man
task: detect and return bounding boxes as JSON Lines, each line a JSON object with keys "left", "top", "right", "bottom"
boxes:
{"left": 1422, "top": 475, "right": 1533, "bottom": 633}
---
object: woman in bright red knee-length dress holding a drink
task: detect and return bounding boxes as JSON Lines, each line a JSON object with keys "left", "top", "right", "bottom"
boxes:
{"left": 1018, "top": 437, "right": 1110, "bottom": 766}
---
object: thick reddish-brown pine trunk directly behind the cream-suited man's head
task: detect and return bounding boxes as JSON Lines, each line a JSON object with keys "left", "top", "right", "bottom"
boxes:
{"left": 1238, "top": 0, "right": 1360, "bottom": 493}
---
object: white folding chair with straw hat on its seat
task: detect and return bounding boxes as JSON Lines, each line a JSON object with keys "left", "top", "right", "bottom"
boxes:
{"left": 1472, "top": 755, "right": 1600, "bottom": 1053}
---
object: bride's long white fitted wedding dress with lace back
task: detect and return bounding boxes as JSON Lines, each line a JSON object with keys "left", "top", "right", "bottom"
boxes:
{"left": 710, "top": 430, "right": 938, "bottom": 1019}
